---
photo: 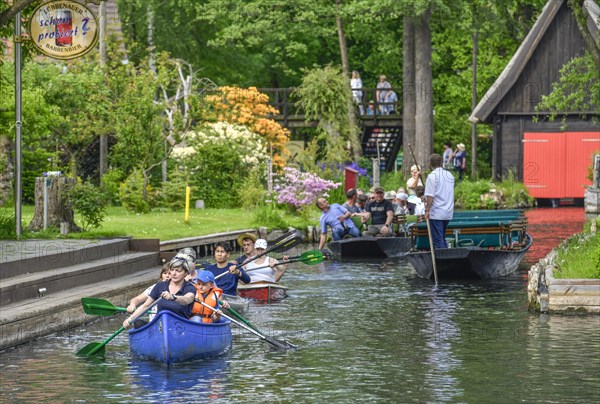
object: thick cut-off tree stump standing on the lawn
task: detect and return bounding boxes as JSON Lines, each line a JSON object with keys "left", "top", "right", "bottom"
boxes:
{"left": 28, "top": 177, "right": 81, "bottom": 231}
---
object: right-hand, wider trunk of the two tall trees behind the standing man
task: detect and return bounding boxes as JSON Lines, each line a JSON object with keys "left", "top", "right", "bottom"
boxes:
{"left": 415, "top": 9, "right": 433, "bottom": 169}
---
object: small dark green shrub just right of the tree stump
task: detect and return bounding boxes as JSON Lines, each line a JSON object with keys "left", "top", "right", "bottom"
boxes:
{"left": 68, "top": 180, "right": 108, "bottom": 231}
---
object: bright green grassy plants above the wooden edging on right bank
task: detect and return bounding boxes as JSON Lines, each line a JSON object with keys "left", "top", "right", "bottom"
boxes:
{"left": 554, "top": 219, "right": 600, "bottom": 279}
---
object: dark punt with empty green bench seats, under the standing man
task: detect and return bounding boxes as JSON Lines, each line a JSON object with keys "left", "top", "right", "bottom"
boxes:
{"left": 405, "top": 210, "right": 533, "bottom": 279}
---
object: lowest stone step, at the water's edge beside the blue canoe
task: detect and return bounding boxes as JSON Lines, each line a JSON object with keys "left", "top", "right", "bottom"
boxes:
{"left": 0, "top": 266, "right": 161, "bottom": 352}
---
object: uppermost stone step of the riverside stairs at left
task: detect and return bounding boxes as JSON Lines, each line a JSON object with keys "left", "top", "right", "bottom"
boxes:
{"left": 0, "top": 238, "right": 131, "bottom": 280}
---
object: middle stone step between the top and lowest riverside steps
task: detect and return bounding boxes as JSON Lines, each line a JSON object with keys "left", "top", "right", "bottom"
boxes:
{"left": 0, "top": 252, "right": 160, "bottom": 310}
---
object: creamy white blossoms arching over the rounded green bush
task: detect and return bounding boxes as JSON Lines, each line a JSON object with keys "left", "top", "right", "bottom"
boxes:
{"left": 172, "top": 122, "right": 269, "bottom": 166}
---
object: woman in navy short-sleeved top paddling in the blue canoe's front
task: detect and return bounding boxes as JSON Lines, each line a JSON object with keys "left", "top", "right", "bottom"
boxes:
{"left": 123, "top": 257, "right": 196, "bottom": 328}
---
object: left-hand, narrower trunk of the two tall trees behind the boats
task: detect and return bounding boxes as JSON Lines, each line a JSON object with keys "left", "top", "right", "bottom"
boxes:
{"left": 402, "top": 17, "right": 416, "bottom": 177}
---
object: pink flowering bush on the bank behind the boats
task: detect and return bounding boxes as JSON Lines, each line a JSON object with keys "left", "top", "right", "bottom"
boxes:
{"left": 275, "top": 167, "right": 342, "bottom": 209}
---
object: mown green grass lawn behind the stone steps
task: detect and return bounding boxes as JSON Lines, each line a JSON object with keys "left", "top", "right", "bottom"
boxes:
{"left": 0, "top": 206, "right": 319, "bottom": 241}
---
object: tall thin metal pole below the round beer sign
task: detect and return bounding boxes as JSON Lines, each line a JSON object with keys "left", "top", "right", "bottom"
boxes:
{"left": 14, "top": 13, "right": 22, "bottom": 240}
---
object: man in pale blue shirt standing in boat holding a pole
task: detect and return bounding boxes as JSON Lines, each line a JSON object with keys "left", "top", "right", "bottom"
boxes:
{"left": 425, "top": 153, "right": 454, "bottom": 249}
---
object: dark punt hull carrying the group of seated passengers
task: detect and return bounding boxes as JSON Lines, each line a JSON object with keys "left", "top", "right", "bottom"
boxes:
{"left": 327, "top": 237, "right": 412, "bottom": 258}
